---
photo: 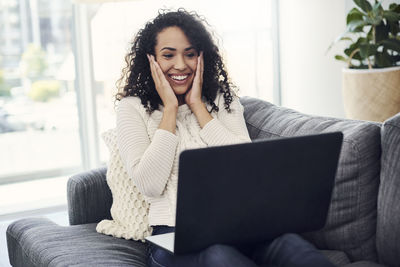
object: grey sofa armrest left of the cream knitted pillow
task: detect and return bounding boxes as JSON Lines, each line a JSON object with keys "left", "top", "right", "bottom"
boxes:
{"left": 67, "top": 167, "right": 112, "bottom": 225}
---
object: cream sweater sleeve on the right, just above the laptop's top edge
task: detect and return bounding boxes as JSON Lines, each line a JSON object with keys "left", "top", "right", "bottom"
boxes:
{"left": 200, "top": 95, "right": 251, "bottom": 146}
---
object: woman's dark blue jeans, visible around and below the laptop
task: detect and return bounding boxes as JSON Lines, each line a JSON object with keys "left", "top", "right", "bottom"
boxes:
{"left": 148, "top": 226, "right": 334, "bottom": 267}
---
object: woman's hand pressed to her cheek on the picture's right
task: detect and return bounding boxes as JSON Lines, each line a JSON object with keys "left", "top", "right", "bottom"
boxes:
{"left": 185, "top": 52, "right": 204, "bottom": 107}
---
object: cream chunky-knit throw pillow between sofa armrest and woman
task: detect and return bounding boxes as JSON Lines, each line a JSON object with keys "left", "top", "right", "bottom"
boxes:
{"left": 96, "top": 129, "right": 152, "bottom": 241}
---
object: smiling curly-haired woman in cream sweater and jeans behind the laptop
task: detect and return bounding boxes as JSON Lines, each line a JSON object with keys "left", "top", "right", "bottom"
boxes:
{"left": 117, "top": 10, "right": 333, "bottom": 267}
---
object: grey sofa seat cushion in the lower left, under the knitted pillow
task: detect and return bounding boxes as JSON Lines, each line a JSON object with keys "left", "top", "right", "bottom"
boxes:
{"left": 7, "top": 218, "right": 147, "bottom": 267}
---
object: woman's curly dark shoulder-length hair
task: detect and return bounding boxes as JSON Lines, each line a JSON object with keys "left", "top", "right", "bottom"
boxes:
{"left": 116, "top": 9, "right": 236, "bottom": 113}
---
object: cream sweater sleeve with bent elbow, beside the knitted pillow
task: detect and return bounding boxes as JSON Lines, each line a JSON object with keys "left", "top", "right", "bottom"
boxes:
{"left": 117, "top": 98, "right": 178, "bottom": 197}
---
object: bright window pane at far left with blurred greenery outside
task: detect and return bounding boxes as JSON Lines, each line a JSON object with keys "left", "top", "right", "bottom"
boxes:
{"left": 0, "top": 0, "right": 81, "bottom": 183}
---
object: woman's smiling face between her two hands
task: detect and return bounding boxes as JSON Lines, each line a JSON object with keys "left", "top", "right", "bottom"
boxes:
{"left": 154, "top": 26, "right": 198, "bottom": 100}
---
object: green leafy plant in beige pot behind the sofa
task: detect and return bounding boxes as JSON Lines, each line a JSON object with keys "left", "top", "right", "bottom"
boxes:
{"left": 334, "top": 0, "right": 400, "bottom": 122}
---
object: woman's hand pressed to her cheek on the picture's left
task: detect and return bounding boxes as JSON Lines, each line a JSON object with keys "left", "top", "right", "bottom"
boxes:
{"left": 147, "top": 55, "right": 178, "bottom": 108}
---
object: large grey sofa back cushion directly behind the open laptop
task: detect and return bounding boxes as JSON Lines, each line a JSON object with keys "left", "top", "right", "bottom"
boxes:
{"left": 241, "top": 97, "right": 381, "bottom": 261}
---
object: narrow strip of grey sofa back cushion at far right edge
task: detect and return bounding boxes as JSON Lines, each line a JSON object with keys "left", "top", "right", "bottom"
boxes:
{"left": 376, "top": 114, "right": 400, "bottom": 266}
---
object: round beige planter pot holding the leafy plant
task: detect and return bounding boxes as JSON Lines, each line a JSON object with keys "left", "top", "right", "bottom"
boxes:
{"left": 343, "top": 67, "right": 400, "bottom": 122}
